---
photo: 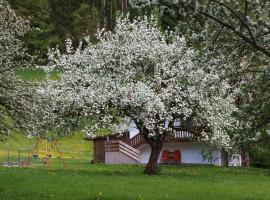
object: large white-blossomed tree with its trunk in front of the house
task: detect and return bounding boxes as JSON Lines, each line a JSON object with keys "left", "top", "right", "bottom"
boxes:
{"left": 41, "top": 18, "right": 236, "bottom": 174}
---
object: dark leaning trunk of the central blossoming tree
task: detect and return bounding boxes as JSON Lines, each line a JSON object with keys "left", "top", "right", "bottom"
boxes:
{"left": 144, "top": 141, "right": 163, "bottom": 175}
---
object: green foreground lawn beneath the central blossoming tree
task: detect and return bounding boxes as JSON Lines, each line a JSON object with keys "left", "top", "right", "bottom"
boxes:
{"left": 0, "top": 164, "right": 270, "bottom": 200}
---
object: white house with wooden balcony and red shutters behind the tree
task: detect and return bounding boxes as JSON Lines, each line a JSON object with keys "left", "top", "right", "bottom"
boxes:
{"left": 86, "top": 119, "right": 250, "bottom": 166}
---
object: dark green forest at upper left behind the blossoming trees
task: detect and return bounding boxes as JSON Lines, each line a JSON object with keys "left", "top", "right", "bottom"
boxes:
{"left": 10, "top": 0, "right": 127, "bottom": 61}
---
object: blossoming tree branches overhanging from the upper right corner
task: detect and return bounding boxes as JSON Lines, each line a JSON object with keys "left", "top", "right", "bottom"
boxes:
{"left": 129, "top": 0, "right": 270, "bottom": 145}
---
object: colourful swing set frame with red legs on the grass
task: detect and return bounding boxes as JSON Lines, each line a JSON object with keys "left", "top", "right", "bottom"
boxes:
{"left": 28, "top": 138, "right": 66, "bottom": 166}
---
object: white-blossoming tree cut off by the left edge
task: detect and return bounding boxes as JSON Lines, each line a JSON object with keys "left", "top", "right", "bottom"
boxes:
{"left": 0, "top": 0, "right": 58, "bottom": 137}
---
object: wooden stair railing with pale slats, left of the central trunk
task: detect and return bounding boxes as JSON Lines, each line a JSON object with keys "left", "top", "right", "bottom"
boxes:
{"left": 105, "top": 140, "right": 140, "bottom": 162}
